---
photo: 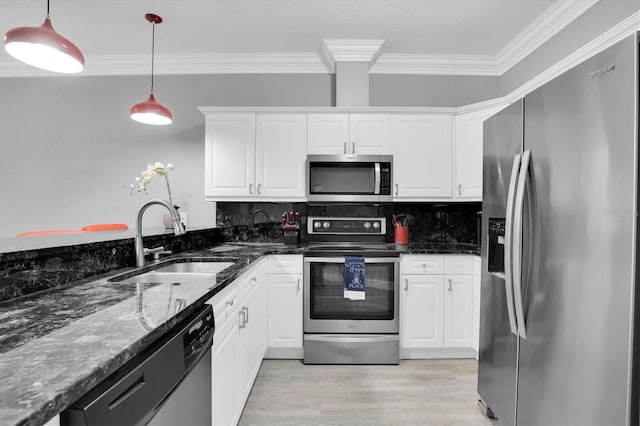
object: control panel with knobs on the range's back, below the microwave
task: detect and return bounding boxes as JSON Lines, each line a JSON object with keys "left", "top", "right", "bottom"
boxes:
{"left": 307, "top": 217, "right": 387, "bottom": 235}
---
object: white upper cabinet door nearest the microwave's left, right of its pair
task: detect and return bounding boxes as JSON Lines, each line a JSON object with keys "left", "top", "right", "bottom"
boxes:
{"left": 256, "top": 114, "right": 307, "bottom": 199}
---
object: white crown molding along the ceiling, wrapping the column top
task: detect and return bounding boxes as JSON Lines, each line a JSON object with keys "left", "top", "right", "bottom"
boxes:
{"left": 0, "top": 0, "right": 616, "bottom": 77}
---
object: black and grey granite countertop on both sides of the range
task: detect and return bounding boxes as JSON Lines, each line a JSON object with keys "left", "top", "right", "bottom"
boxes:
{"left": 0, "top": 243, "right": 472, "bottom": 425}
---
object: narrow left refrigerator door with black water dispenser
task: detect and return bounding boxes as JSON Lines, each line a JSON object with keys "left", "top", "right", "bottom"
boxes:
{"left": 478, "top": 101, "right": 523, "bottom": 425}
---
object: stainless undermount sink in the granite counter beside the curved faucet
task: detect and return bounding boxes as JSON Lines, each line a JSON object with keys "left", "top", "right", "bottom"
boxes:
{"left": 109, "top": 261, "right": 235, "bottom": 283}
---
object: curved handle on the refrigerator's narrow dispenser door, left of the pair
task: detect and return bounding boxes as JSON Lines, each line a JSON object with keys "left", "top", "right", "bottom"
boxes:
{"left": 504, "top": 154, "right": 521, "bottom": 336}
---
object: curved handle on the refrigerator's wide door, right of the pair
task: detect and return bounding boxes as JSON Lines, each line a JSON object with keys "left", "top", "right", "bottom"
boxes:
{"left": 512, "top": 150, "right": 531, "bottom": 339}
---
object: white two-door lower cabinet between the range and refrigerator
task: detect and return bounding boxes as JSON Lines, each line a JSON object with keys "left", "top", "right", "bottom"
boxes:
{"left": 400, "top": 255, "right": 475, "bottom": 358}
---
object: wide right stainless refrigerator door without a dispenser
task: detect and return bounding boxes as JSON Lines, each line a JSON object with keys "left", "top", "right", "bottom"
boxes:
{"left": 516, "top": 36, "right": 638, "bottom": 425}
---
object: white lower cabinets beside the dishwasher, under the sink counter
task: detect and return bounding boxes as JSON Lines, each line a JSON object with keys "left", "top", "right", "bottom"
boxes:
{"left": 207, "top": 260, "right": 267, "bottom": 425}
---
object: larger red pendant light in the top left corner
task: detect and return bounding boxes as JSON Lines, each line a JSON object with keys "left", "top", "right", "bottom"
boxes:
{"left": 4, "top": 0, "right": 84, "bottom": 74}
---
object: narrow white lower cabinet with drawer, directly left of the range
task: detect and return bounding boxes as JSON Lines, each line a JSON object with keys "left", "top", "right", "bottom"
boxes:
{"left": 266, "top": 255, "right": 304, "bottom": 359}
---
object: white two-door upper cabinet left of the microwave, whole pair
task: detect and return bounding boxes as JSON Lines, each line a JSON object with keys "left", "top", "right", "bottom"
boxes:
{"left": 205, "top": 113, "right": 307, "bottom": 201}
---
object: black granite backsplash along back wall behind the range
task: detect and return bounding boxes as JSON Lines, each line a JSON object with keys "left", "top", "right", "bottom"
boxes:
{"left": 216, "top": 202, "right": 482, "bottom": 244}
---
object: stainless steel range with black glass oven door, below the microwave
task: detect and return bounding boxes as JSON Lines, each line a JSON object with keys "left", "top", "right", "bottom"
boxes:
{"left": 304, "top": 217, "right": 400, "bottom": 364}
